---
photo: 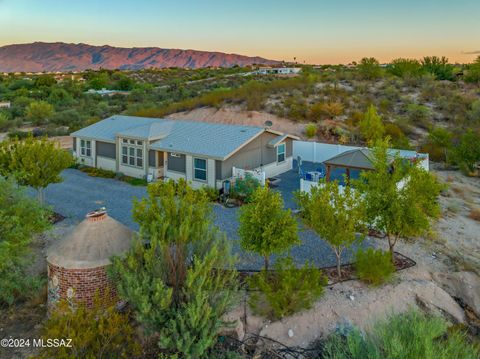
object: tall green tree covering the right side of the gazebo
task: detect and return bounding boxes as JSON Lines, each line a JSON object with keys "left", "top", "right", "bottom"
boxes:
{"left": 355, "top": 139, "right": 442, "bottom": 261}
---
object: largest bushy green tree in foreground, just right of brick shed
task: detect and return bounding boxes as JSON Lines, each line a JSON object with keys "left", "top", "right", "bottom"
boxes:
{"left": 110, "top": 180, "right": 236, "bottom": 358}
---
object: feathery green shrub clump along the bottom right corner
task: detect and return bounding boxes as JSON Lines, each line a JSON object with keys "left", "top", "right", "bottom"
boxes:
{"left": 321, "top": 310, "right": 480, "bottom": 359}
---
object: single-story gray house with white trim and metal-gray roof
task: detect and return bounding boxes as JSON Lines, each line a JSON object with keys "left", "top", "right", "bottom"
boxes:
{"left": 71, "top": 115, "right": 297, "bottom": 189}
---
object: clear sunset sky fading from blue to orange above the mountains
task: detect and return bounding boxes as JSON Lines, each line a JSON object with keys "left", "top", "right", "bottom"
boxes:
{"left": 0, "top": 0, "right": 480, "bottom": 64}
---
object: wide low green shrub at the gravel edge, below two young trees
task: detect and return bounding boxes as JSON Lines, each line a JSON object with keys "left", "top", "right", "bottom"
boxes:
{"left": 248, "top": 257, "right": 327, "bottom": 319}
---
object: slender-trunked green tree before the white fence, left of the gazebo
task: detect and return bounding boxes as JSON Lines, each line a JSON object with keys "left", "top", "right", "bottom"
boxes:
{"left": 296, "top": 181, "right": 365, "bottom": 278}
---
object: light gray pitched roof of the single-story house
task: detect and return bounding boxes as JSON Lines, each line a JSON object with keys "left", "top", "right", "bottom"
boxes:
{"left": 72, "top": 115, "right": 264, "bottom": 159}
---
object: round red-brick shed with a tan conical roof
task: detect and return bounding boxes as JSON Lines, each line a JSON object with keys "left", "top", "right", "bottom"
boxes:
{"left": 47, "top": 208, "right": 133, "bottom": 308}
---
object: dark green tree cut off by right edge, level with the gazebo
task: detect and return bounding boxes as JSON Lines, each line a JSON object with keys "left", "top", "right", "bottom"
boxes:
{"left": 454, "top": 129, "right": 480, "bottom": 175}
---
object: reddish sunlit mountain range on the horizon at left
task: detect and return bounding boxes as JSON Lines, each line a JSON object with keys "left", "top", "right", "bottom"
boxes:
{"left": 0, "top": 42, "right": 279, "bottom": 72}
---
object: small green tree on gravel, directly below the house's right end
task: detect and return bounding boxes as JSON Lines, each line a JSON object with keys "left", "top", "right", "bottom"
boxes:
{"left": 238, "top": 186, "right": 300, "bottom": 269}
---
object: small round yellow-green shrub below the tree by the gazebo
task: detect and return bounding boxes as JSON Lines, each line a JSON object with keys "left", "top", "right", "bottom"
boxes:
{"left": 355, "top": 248, "right": 395, "bottom": 286}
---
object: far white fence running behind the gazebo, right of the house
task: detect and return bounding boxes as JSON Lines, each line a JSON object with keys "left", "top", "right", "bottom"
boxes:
{"left": 293, "top": 141, "right": 430, "bottom": 171}
